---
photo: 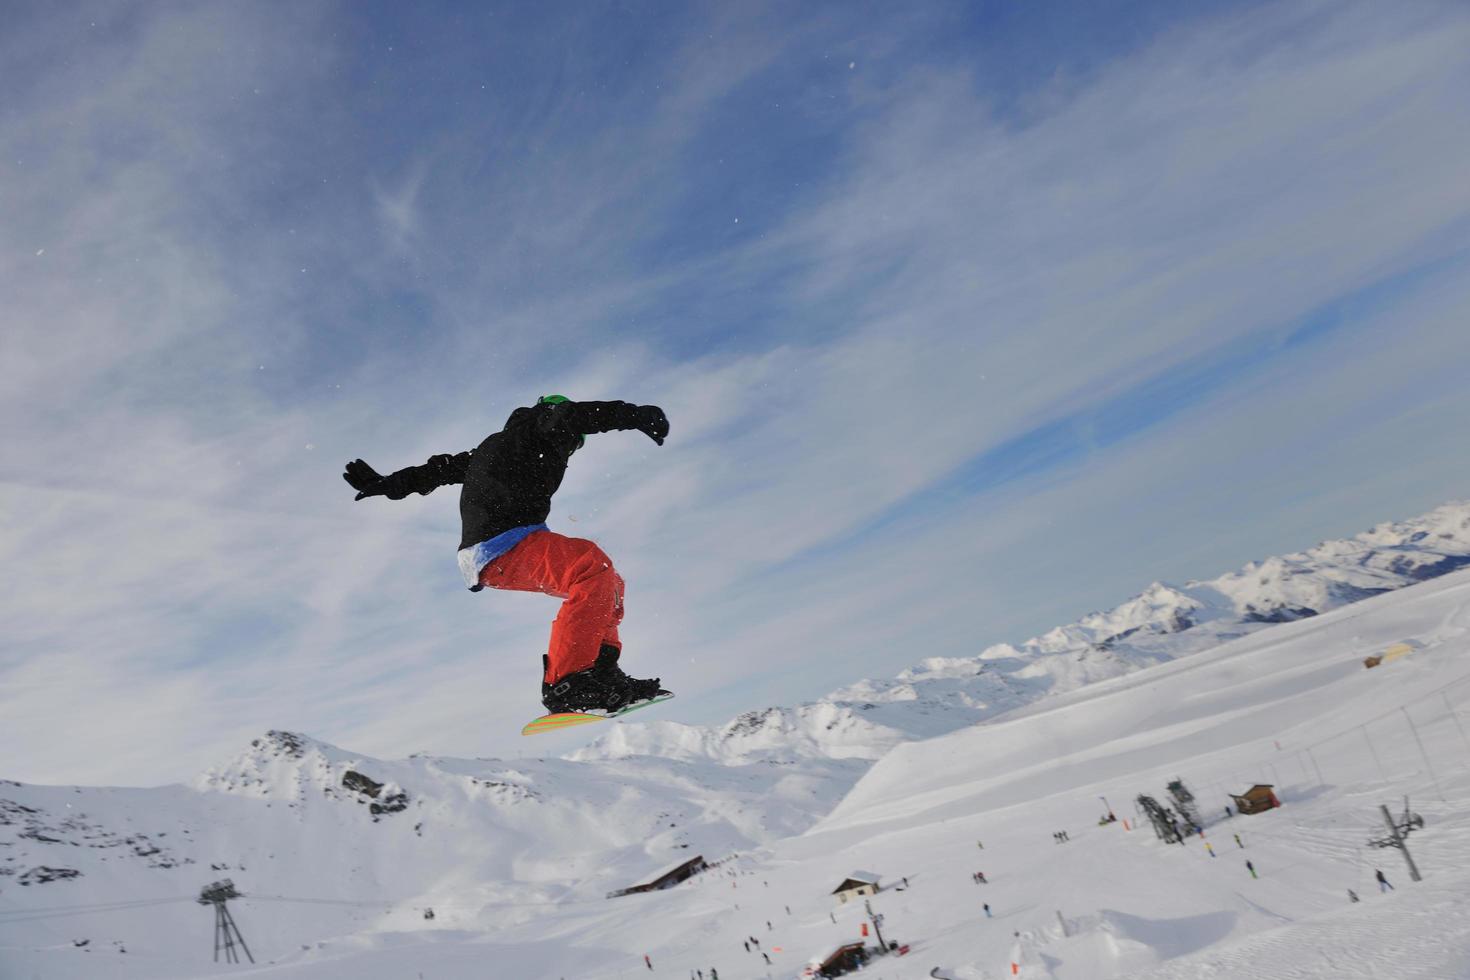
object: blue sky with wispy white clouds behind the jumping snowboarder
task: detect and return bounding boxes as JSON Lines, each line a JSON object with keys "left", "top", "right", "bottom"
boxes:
{"left": 0, "top": 3, "right": 1470, "bottom": 783}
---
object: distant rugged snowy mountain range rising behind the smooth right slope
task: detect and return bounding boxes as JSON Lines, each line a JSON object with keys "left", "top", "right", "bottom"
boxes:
{"left": 573, "top": 501, "right": 1470, "bottom": 763}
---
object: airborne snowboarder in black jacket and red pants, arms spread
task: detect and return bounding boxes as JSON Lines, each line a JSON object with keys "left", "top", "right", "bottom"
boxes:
{"left": 343, "top": 395, "right": 669, "bottom": 714}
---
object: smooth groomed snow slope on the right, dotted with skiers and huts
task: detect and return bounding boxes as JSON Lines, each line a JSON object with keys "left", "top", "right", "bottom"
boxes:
{"left": 779, "top": 573, "right": 1470, "bottom": 979}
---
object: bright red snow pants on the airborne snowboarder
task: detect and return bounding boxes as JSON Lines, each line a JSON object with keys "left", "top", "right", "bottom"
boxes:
{"left": 479, "top": 530, "right": 623, "bottom": 683}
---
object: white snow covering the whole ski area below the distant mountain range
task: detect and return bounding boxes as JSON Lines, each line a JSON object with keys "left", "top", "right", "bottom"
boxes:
{"left": 0, "top": 572, "right": 1470, "bottom": 980}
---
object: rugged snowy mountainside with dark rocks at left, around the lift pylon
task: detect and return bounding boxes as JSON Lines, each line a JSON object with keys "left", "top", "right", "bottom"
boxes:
{"left": 0, "top": 732, "right": 864, "bottom": 977}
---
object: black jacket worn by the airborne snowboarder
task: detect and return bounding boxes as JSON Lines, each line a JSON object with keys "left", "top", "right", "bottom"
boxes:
{"left": 384, "top": 401, "right": 652, "bottom": 551}
